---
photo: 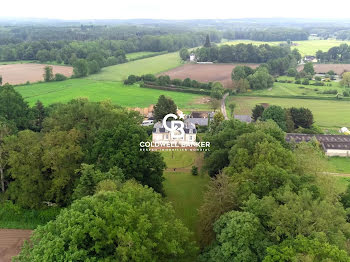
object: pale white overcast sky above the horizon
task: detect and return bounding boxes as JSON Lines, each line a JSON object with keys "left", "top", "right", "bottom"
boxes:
{"left": 4, "top": 0, "right": 350, "bottom": 20}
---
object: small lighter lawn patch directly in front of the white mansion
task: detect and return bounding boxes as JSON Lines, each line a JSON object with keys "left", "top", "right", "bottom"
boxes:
{"left": 161, "top": 151, "right": 198, "bottom": 168}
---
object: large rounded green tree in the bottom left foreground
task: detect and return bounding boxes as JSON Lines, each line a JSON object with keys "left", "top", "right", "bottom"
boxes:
{"left": 15, "top": 182, "right": 196, "bottom": 262}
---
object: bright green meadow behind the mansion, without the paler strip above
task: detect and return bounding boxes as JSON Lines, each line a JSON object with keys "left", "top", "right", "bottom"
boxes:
{"left": 16, "top": 78, "right": 209, "bottom": 109}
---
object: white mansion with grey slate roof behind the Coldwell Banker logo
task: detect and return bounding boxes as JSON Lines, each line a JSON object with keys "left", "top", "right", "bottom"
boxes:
{"left": 152, "top": 121, "right": 197, "bottom": 146}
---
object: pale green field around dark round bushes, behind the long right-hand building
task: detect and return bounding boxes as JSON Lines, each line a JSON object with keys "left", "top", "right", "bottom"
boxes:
{"left": 230, "top": 96, "right": 350, "bottom": 129}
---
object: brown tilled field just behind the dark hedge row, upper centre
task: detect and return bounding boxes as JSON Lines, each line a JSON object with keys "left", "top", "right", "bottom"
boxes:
{"left": 162, "top": 64, "right": 258, "bottom": 87}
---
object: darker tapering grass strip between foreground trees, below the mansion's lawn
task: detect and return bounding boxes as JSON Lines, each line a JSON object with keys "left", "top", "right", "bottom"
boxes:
{"left": 164, "top": 172, "right": 210, "bottom": 240}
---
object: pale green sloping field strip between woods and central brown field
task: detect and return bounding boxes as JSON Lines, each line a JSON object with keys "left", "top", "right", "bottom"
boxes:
{"left": 87, "top": 52, "right": 181, "bottom": 81}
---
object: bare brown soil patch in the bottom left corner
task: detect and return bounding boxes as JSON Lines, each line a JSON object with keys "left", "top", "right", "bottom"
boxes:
{"left": 0, "top": 229, "right": 32, "bottom": 262}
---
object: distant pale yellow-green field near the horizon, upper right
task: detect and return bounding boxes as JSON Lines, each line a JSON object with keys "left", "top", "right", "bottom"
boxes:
{"left": 222, "top": 39, "right": 350, "bottom": 56}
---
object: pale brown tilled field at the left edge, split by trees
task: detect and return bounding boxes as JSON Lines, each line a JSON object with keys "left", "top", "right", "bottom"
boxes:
{"left": 0, "top": 64, "right": 73, "bottom": 85}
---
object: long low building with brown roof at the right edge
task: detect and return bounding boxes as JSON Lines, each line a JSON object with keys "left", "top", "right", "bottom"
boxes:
{"left": 286, "top": 134, "right": 350, "bottom": 157}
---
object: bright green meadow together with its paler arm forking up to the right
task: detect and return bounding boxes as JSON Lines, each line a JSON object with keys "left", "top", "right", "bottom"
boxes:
{"left": 16, "top": 53, "right": 208, "bottom": 110}
